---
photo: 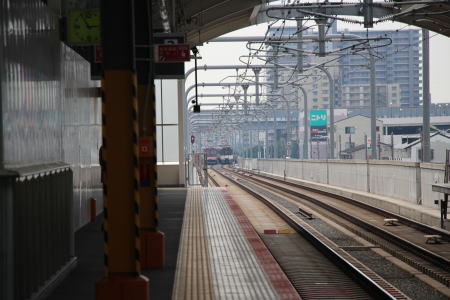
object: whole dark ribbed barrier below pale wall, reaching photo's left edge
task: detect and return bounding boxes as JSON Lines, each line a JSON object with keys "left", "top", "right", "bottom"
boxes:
{"left": 0, "top": 164, "right": 76, "bottom": 300}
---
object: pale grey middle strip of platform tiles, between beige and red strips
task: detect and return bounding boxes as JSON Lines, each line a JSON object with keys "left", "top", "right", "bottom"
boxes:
{"left": 202, "top": 188, "right": 278, "bottom": 299}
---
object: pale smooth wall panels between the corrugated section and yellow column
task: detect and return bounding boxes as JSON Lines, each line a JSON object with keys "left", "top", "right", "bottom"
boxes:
{"left": 61, "top": 46, "right": 103, "bottom": 229}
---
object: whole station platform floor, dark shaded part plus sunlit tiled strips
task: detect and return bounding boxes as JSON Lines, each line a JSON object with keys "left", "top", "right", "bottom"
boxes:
{"left": 45, "top": 186, "right": 300, "bottom": 300}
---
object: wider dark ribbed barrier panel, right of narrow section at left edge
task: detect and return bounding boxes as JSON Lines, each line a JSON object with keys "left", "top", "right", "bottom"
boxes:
{"left": 13, "top": 165, "right": 74, "bottom": 300}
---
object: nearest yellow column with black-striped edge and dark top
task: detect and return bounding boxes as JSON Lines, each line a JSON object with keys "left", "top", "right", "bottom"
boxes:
{"left": 96, "top": 0, "right": 149, "bottom": 300}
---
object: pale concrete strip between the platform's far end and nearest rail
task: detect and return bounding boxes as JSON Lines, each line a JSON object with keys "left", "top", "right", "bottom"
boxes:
{"left": 208, "top": 170, "right": 294, "bottom": 233}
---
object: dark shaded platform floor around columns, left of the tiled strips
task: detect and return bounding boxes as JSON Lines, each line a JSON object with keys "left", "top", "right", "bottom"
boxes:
{"left": 46, "top": 188, "right": 186, "bottom": 300}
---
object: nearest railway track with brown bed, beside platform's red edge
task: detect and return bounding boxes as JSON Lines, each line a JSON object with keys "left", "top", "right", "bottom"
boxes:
{"left": 209, "top": 170, "right": 409, "bottom": 299}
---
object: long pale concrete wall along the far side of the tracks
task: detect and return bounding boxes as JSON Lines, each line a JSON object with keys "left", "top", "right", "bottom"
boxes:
{"left": 238, "top": 158, "right": 444, "bottom": 209}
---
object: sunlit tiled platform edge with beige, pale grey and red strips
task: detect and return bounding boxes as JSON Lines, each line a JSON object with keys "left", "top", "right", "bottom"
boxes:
{"left": 173, "top": 187, "right": 300, "bottom": 300}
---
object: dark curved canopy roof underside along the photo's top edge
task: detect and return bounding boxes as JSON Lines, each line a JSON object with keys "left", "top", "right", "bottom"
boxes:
{"left": 168, "top": 0, "right": 450, "bottom": 44}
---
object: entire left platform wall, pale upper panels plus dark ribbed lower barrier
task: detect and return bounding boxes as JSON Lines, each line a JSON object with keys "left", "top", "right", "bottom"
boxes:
{"left": 0, "top": 0, "right": 102, "bottom": 300}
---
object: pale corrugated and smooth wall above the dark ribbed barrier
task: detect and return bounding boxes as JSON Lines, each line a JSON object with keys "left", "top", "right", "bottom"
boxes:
{"left": 0, "top": 0, "right": 102, "bottom": 228}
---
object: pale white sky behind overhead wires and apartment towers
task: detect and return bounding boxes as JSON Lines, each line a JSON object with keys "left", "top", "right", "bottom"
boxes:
{"left": 186, "top": 18, "right": 450, "bottom": 103}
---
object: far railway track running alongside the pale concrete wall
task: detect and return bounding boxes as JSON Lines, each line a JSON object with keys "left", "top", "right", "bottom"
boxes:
{"left": 225, "top": 166, "right": 450, "bottom": 287}
